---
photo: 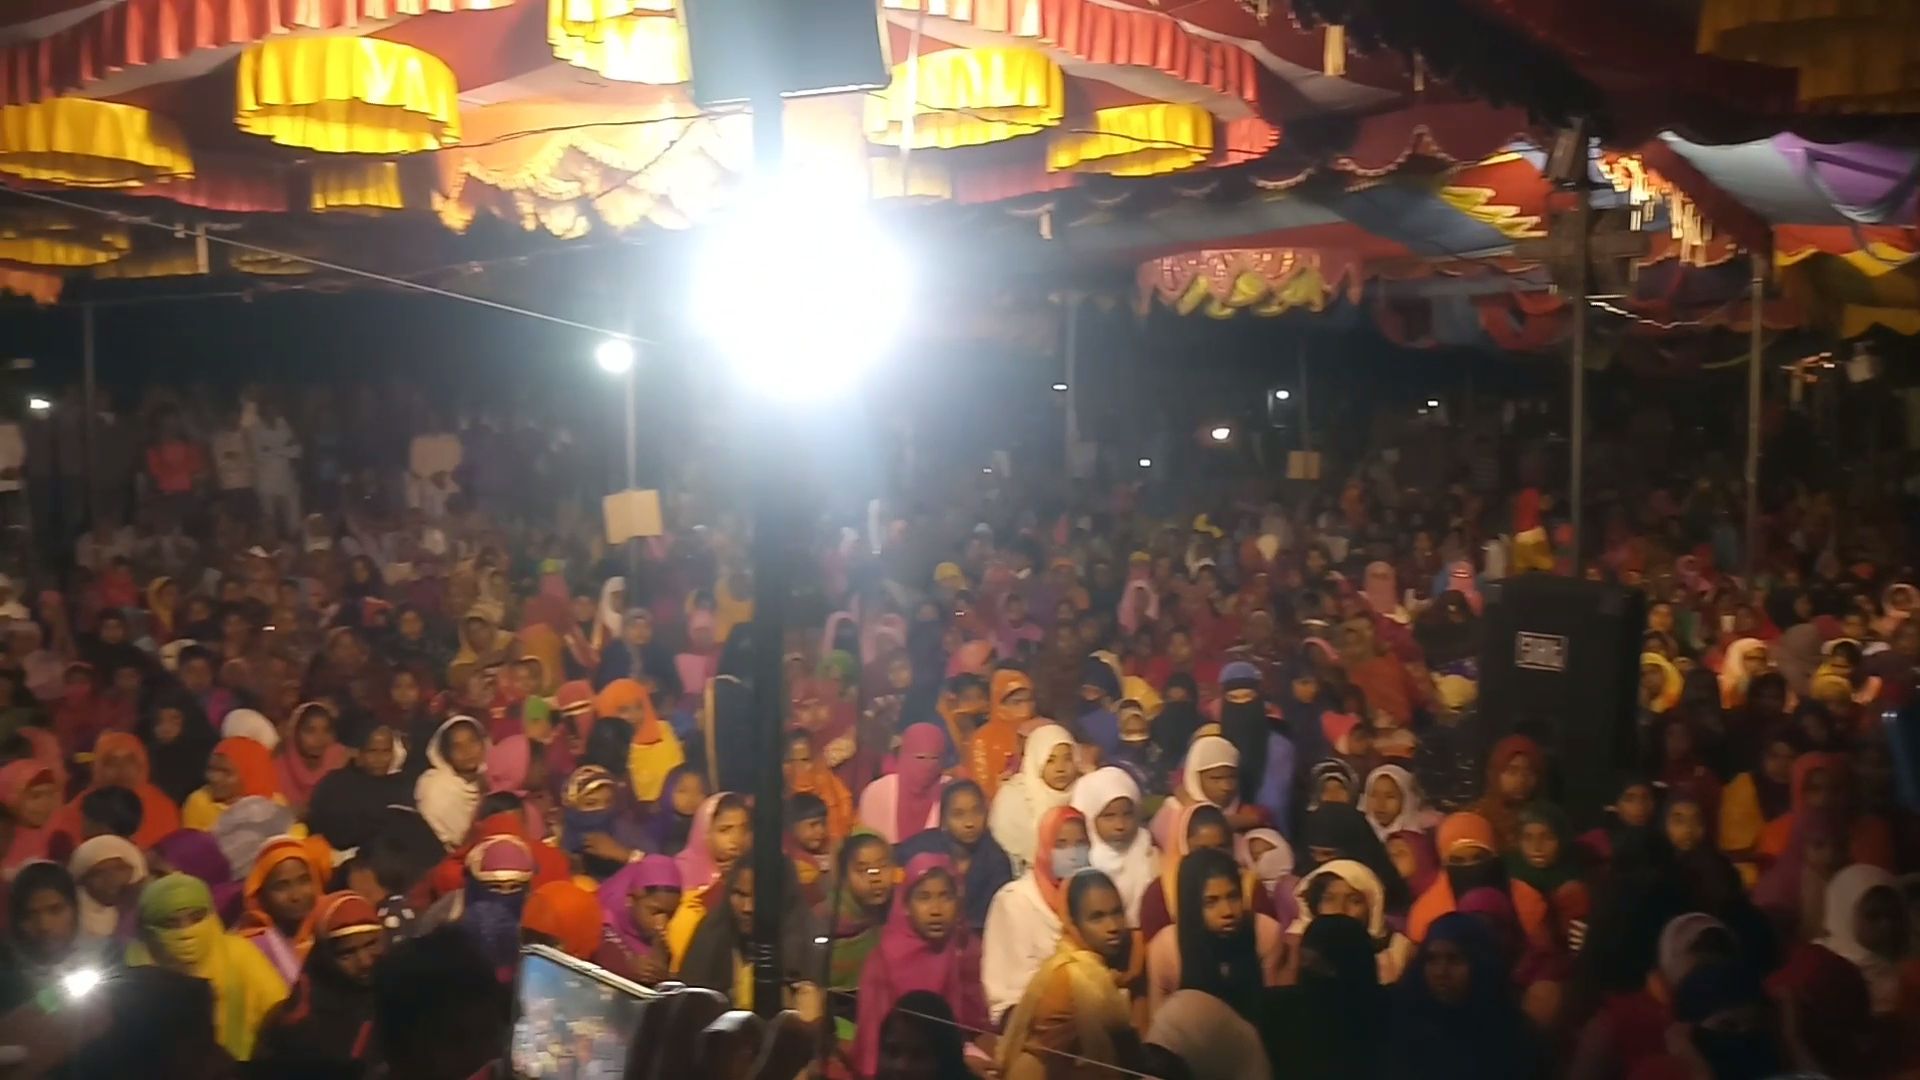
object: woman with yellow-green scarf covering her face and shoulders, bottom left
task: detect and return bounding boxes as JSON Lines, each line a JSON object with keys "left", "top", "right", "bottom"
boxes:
{"left": 127, "top": 874, "right": 286, "bottom": 1061}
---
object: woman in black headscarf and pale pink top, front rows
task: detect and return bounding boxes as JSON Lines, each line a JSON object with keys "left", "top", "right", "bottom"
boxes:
{"left": 1146, "top": 847, "right": 1286, "bottom": 1017}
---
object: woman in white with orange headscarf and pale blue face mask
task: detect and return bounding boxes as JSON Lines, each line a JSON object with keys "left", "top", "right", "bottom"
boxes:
{"left": 981, "top": 805, "right": 1091, "bottom": 1024}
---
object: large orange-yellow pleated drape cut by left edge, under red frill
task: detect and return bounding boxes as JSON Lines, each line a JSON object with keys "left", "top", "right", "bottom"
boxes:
{"left": 0, "top": 98, "right": 194, "bottom": 188}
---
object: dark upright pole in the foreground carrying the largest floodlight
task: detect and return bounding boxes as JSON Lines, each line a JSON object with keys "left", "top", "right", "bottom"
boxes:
{"left": 741, "top": 92, "right": 797, "bottom": 1019}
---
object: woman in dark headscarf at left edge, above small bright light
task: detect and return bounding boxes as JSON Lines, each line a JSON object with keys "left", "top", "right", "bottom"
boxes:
{"left": 0, "top": 859, "right": 125, "bottom": 1013}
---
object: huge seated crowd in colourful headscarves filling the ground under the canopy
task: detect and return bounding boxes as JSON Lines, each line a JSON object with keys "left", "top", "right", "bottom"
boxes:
{"left": 0, "top": 374, "right": 1920, "bottom": 1080}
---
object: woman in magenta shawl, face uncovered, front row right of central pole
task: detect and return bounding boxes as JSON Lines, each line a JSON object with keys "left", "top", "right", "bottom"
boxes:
{"left": 852, "top": 853, "right": 987, "bottom": 1076}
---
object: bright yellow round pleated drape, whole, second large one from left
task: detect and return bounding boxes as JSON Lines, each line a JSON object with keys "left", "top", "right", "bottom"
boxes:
{"left": 234, "top": 37, "right": 461, "bottom": 154}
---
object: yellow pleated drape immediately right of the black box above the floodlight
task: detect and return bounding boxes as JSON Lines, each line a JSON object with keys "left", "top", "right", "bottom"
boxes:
{"left": 866, "top": 48, "right": 1066, "bottom": 150}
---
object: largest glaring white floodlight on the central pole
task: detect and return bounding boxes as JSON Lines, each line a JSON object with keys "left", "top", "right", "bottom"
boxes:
{"left": 689, "top": 175, "right": 912, "bottom": 402}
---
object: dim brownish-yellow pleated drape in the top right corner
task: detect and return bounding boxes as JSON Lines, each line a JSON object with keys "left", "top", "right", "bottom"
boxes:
{"left": 1699, "top": 0, "right": 1920, "bottom": 111}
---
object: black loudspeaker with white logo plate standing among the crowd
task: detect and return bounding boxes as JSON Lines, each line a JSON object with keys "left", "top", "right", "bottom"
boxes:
{"left": 1480, "top": 573, "right": 1647, "bottom": 830}
